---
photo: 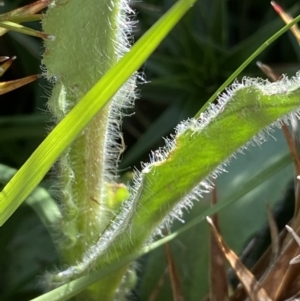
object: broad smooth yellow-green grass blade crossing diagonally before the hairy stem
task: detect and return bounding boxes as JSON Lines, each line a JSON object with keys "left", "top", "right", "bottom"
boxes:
{"left": 0, "top": 0, "right": 196, "bottom": 225}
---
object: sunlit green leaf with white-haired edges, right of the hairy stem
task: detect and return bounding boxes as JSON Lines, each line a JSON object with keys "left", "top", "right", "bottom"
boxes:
{"left": 96, "top": 77, "right": 300, "bottom": 266}
